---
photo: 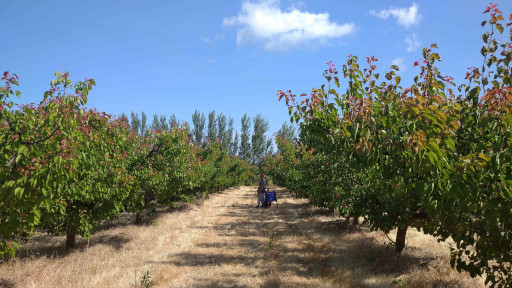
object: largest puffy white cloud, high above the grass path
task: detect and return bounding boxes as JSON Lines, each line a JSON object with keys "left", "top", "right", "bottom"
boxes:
{"left": 223, "top": 0, "right": 356, "bottom": 50}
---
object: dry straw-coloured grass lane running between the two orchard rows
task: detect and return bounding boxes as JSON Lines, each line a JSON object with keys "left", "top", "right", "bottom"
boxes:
{"left": 0, "top": 187, "right": 484, "bottom": 288}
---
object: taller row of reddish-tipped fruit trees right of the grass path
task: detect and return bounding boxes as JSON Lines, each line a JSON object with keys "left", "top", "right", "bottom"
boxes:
{"left": 264, "top": 4, "right": 512, "bottom": 287}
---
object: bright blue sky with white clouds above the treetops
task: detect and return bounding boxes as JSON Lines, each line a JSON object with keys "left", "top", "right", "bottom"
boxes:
{"left": 0, "top": 0, "right": 512, "bottom": 137}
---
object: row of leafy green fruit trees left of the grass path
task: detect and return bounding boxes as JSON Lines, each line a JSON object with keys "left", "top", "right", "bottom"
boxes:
{"left": 0, "top": 72, "right": 254, "bottom": 256}
